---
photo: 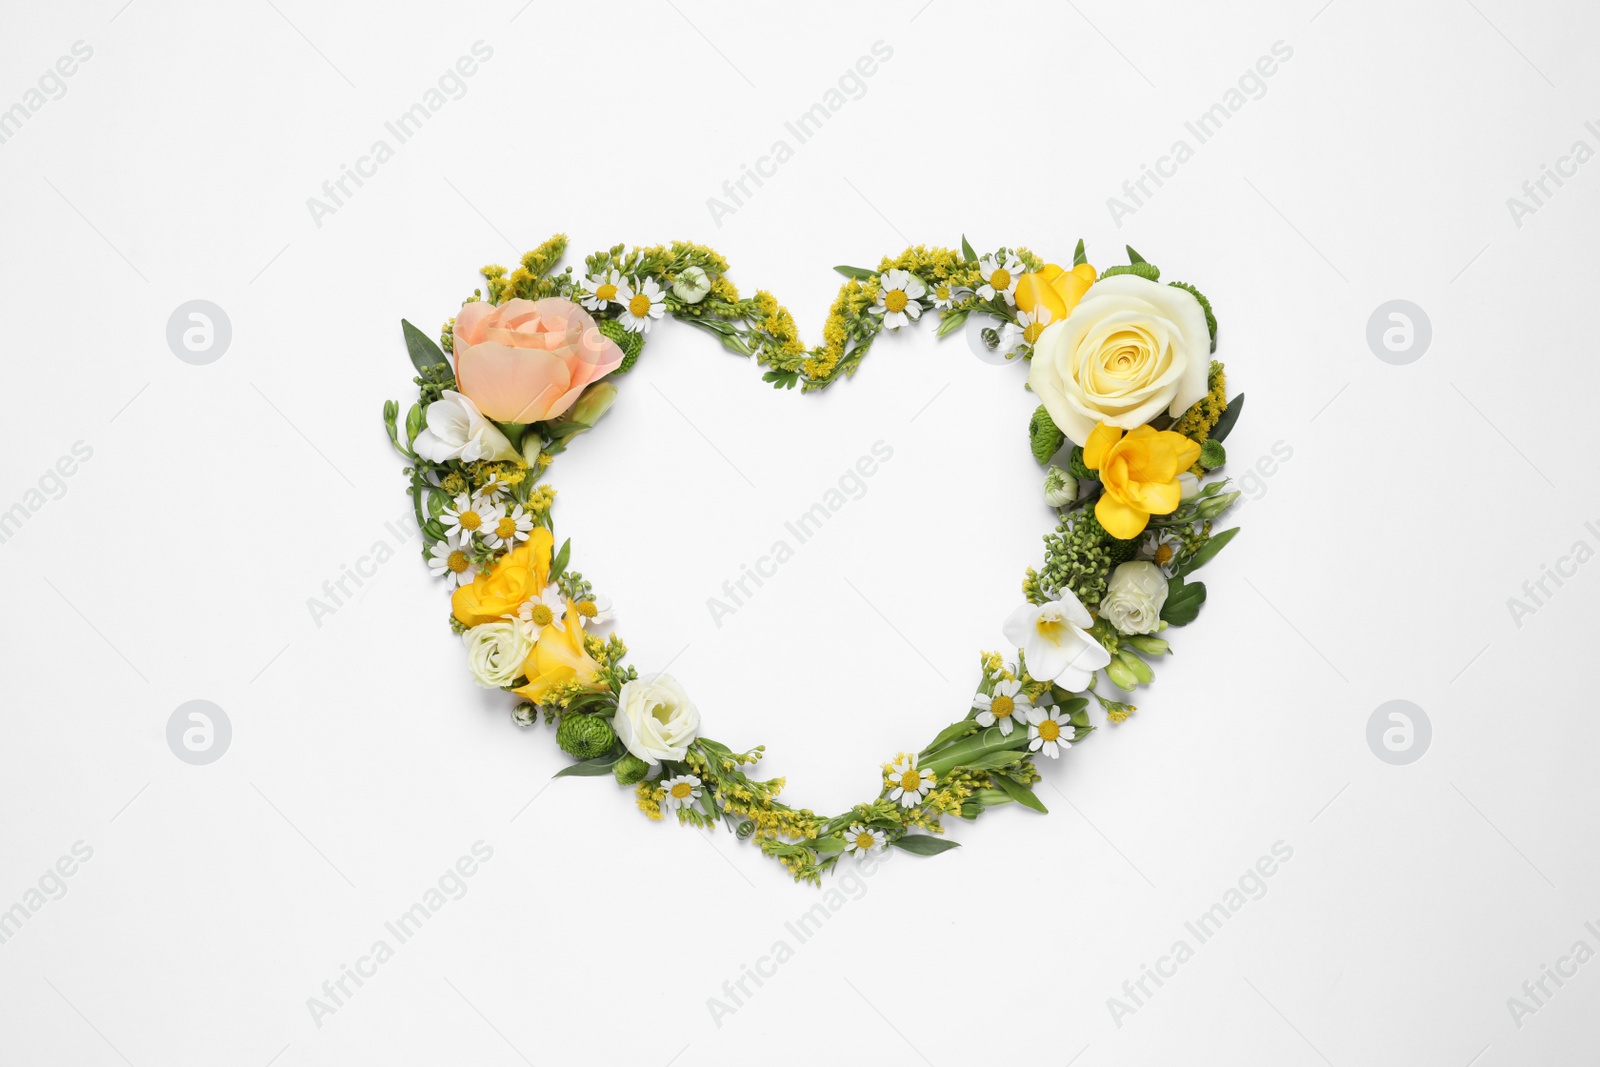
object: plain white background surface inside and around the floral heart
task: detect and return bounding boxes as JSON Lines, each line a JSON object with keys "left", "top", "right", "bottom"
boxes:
{"left": 0, "top": 0, "right": 1600, "bottom": 1067}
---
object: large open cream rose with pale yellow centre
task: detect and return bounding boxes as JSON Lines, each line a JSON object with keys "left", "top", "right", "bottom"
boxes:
{"left": 1027, "top": 274, "right": 1211, "bottom": 445}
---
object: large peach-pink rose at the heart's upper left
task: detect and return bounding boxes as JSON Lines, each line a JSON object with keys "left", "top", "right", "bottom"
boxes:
{"left": 456, "top": 296, "right": 622, "bottom": 422}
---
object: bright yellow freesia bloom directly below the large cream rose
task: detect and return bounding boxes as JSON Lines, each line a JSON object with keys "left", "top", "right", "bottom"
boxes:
{"left": 1083, "top": 422, "right": 1200, "bottom": 541}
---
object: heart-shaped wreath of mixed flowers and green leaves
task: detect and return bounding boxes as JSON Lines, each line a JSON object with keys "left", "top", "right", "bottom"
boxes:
{"left": 384, "top": 237, "right": 1243, "bottom": 881}
